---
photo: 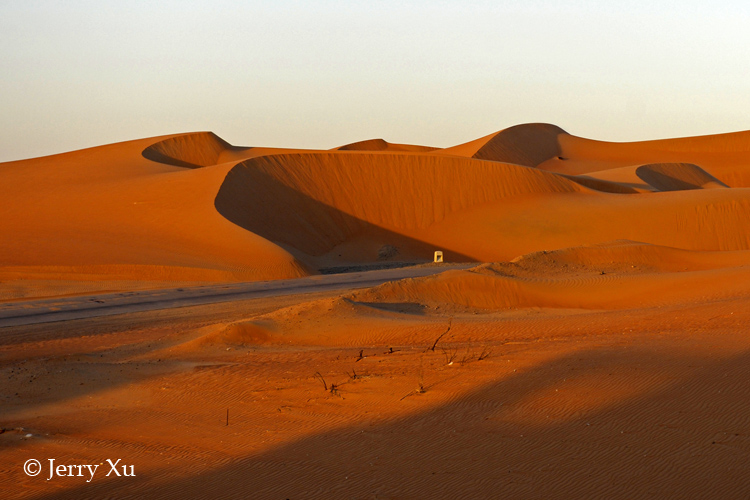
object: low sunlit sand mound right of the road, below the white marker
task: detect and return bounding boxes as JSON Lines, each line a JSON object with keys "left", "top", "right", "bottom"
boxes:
{"left": 351, "top": 242, "right": 750, "bottom": 309}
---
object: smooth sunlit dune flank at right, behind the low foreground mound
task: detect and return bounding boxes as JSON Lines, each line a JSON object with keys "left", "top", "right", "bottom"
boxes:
{"left": 416, "top": 189, "right": 750, "bottom": 262}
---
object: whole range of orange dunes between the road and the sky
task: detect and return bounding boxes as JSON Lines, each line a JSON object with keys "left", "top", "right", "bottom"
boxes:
{"left": 0, "top": 124, "right": 750, "bottom": 296}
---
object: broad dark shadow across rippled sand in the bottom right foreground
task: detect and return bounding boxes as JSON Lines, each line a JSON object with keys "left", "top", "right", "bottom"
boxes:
{"left": 32, "top": 346, "right": 750, "bottom": 499}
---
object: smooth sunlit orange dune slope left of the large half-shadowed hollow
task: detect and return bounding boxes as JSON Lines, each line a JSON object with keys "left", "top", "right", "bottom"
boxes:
{"left": 0, "top": 134, "right": 306, "bottom": 280}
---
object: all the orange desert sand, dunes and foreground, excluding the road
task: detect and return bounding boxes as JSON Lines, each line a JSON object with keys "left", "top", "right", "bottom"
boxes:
{"left": 0, "top": 124, "right": 750, "bottom": 499}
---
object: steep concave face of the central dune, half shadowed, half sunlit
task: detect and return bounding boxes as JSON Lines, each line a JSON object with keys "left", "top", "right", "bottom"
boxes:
{"left": 216, "top": 153, "right": 586, "bottom": 255}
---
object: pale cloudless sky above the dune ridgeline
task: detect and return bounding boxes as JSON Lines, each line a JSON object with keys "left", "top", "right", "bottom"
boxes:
{"left": 0, "top": 0, "right": 750, "bottom": 162}
